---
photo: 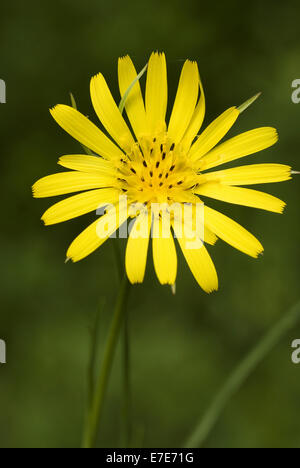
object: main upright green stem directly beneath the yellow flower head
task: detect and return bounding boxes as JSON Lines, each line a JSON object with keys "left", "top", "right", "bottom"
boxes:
{"left": 82, "top": 275, "right": 130, "bottom": 448}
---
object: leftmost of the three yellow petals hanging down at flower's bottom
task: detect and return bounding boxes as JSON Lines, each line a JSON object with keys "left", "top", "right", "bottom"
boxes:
{"left": 125, "top": 212, "right": 151, "bottom": 284}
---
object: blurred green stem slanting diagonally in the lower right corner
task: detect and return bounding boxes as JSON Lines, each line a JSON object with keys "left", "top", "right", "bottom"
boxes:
{"left": 184, "top": 302, "right": 300, "bottom": 448}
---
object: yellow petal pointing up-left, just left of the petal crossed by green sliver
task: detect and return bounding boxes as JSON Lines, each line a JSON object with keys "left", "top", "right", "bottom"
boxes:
{"left": 90, "top": 73, "right": 134, "bottom": 150}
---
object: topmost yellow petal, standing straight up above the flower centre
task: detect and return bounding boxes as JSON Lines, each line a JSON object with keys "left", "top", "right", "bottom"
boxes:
{"left": 146, "top": 52, "right": 168, "bottom": 134}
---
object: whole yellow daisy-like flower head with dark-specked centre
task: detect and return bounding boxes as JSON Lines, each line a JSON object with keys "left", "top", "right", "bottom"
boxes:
{"left": 33, "top": 53, "right": 291, "bottom": 292}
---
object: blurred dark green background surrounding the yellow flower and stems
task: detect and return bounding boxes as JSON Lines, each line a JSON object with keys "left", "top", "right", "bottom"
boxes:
{"left": 0, "top": 0, "right": 300, "bottom": 448}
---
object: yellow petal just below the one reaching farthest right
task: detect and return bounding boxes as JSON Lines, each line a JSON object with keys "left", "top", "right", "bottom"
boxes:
{"left": 196, "top": 182, "right": 285, "bottom": 213}
